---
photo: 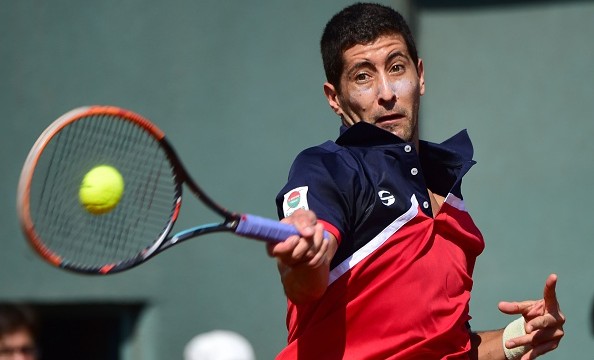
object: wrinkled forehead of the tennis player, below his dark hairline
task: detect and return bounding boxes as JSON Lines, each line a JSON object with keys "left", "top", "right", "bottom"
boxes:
{"left": 342, "top": 34, "right": 411, "bottom": 70}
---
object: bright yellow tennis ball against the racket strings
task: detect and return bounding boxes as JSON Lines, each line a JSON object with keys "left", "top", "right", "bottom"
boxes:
{"left": 78, "top": 165, "right": 124, "bottom": 215}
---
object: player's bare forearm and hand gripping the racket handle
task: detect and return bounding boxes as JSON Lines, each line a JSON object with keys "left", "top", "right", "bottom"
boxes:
{"left": 268, "top": 210, "right": 338, "bottom": 304}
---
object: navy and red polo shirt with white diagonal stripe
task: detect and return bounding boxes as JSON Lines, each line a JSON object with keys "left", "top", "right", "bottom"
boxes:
{"left": 276, "top": 122, "right": 484, "bottom": 360}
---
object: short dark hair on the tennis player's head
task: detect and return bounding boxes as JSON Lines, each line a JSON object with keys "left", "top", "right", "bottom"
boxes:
{"left": 320, "top": 3, "right": 419, "bottom": 87}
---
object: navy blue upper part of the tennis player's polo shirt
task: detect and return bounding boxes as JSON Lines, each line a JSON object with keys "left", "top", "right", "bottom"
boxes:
{"left": 276, "top": 122, "right": 474, "bottom": 268}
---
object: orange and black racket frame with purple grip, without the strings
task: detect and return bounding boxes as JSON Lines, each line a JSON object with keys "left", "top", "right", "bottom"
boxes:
{"left": 17, "top": 105, "right": 306, "bottom": 275}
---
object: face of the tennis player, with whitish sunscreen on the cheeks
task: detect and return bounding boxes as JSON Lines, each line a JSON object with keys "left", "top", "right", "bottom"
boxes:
{"left": 324, "top": 34, "right": 425, "bottom": 142}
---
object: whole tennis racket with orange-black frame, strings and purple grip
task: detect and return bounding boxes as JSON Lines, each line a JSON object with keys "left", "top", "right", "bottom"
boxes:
{"left": 17, "top": 106, "right": 308, "bottom": 274}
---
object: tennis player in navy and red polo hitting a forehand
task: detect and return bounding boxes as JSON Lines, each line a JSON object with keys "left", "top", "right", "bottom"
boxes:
{"left": 268, "top": 4, "right": 565, "bottom": 360}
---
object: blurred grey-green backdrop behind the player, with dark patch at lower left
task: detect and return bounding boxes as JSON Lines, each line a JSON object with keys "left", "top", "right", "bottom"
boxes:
{"left": 0, "top": 0, "right": 594, "bottom": 360}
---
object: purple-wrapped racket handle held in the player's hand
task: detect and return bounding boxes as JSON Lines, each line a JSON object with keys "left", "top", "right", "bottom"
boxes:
{"left": 235, "top": 214, "right": 328, "bottom": 242}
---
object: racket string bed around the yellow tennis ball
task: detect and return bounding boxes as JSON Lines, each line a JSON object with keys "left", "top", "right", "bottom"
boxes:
{"left": 30, "top": 115, "right": 179, "bottom": 267}
